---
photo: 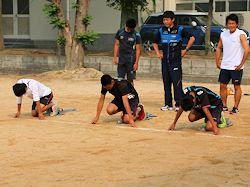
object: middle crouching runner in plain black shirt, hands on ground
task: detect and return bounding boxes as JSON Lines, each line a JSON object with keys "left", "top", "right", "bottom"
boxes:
{"left": 92, "top": 75, "right": 145, "bottom": 127}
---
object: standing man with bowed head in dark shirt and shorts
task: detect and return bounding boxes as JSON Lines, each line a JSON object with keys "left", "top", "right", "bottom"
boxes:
{"left": 113, "top": 19, "right": 141, "bottom": 84}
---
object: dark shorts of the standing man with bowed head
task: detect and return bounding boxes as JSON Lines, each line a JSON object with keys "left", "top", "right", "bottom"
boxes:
{"left": 117, "top": 63, "right": 136, "bottom": 81}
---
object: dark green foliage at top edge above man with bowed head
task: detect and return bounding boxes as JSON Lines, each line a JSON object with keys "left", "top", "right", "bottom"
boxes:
{"left": 106, "top": 0, "right": 148, "bottom": 12}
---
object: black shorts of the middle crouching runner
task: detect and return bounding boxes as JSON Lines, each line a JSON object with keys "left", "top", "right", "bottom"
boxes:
{"left": 111, "top": 98, "right": 139, "bottom": 116}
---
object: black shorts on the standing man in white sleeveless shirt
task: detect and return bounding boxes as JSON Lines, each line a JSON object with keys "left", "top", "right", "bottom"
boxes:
{"left": 218, "top": 69, "right": 243, "bottom": 85}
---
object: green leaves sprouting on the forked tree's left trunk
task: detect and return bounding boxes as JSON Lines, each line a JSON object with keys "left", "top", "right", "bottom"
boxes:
{"left": 43, "top": 3, "right": 67, "bottom": 29}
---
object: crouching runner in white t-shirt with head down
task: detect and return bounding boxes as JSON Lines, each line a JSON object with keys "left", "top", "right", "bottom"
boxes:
{"left": 13, "top": 79, "right": 56, "bottom": 120}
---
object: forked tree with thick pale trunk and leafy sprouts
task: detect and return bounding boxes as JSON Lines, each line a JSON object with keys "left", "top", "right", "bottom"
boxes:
{"left": 43, "top": 0, "right": 97, "bottom": 69}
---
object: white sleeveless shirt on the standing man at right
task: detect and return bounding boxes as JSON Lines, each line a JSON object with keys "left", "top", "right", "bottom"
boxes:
{"left": 220, "top": 29, "right": 247, "bottom": 70}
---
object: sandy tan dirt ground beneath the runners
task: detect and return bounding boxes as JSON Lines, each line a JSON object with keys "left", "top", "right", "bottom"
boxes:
{"left": 0, "top": 74, "right": 250, "bottom": 187}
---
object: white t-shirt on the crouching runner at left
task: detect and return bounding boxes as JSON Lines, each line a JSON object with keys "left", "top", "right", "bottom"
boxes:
{"left": 17, "top": 79, "right": 51, "bottom": 104}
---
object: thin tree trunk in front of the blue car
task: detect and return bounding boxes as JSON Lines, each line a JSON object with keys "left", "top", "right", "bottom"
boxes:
{"left": 205, "top": 0, "right": 214, "bottom": 54}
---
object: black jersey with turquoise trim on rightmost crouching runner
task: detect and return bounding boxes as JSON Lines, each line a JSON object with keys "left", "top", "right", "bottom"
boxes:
{"left": 184, "top": 86, "right": 222, "bottom": 109}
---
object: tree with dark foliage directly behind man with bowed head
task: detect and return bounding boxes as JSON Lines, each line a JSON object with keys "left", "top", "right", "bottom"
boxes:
{"left": 106, "top": 0, "right": 148, "bottom": 28}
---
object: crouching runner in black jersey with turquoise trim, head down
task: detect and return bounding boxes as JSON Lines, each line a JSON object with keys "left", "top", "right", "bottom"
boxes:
{"left": 169, "top": 86, "right": 223, "bottom": 135}
